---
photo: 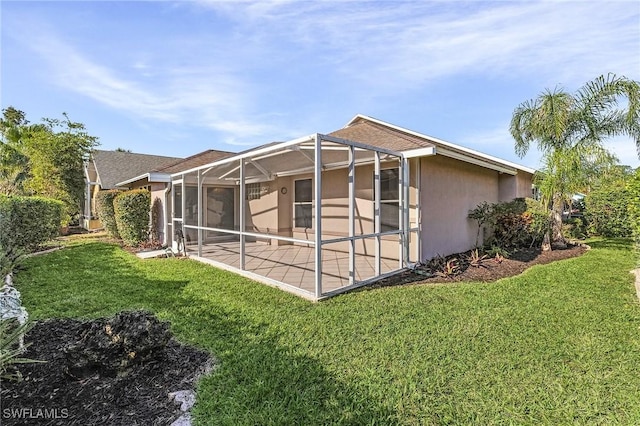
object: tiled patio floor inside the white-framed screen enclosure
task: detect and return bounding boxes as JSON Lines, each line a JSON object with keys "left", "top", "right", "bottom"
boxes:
{"left": 182, "top": 241, "right": 400, "bottom": 296}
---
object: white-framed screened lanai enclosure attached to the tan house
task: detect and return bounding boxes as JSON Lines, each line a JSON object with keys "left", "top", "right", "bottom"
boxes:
{"left": 171, "top": 134, "right": 420, "bottom": 300}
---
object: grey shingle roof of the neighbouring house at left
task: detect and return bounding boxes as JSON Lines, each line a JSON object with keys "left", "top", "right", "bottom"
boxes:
{"left": 92, "top": 150, "right": 181, "bottom": 189}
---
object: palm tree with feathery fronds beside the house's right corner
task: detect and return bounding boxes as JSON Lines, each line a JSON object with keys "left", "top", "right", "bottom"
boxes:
{"left": 509, "top": 74, "right": 640, "bottom": 244}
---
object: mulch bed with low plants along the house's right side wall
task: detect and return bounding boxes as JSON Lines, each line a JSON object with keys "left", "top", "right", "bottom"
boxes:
{"left": 368, "top": 245, "right": 587, "bottom": 288}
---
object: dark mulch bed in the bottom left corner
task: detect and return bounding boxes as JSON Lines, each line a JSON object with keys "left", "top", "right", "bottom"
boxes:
{"left": 0, "top": 316, "right": 211, "bottom": 425}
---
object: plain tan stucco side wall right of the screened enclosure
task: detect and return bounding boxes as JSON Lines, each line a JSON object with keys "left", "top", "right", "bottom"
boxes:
{"left": 421, "top": 156, "right": 499, "bottom": 260}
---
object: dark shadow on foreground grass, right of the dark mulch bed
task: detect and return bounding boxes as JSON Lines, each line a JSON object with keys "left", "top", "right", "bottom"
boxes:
{"left": 165, "top": 297, "right": 398, "bottom": 425}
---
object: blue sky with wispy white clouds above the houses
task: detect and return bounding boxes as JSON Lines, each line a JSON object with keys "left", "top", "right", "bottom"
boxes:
{"left": 0, "top": 0, "right": 640, "bottom": 167}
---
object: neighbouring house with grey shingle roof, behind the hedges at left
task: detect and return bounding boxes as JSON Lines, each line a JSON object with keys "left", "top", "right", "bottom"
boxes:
{"left": 81, "top": 150, "right": 181, "bottom": 230}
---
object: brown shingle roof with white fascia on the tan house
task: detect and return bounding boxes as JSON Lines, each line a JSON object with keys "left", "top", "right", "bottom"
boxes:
{"left": 329, "top": 114, "right": 535, "bottom": 174}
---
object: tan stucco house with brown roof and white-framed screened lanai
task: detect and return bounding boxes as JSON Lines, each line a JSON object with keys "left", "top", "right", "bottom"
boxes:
{"left": 168, "top": 115, "right": 534, "bottom": 300}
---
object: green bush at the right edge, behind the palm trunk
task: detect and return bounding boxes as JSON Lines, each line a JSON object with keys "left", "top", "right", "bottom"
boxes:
{"left": 585, "top": 187, "right": 632, "bottom": 237}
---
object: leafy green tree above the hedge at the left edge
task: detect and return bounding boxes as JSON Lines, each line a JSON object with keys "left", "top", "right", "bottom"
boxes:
{"left": 0, "top": 107, "right": 98, "bottom": 220}
